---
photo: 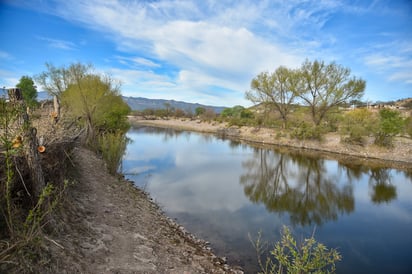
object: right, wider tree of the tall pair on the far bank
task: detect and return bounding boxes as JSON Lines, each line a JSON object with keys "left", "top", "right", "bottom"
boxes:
{"left": 297, "top": 60, "right": 366, "bottom": 126}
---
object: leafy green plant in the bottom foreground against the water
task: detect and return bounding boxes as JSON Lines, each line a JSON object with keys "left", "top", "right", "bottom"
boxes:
{"left": 254, "top": 226, "right": 342, "bottom": 274}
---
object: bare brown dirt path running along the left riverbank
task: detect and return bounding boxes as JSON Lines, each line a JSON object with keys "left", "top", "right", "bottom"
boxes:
{"left": 52, "top": 148, "right": 242, "bottom": 274}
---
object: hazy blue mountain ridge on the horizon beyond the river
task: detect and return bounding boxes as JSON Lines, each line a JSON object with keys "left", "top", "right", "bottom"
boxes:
{"left": 122, "top": 96, "right": 226, "bottom": 113}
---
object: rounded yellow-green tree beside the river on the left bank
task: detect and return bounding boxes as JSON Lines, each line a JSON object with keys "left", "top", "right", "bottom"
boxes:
{"left": 62, "top": 74, "right": 130, "bottom": 144}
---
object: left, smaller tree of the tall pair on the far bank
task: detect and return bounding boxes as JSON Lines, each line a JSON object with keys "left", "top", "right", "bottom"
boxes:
{"left": 246, "top": 66, "right": 299, "bottom": 128}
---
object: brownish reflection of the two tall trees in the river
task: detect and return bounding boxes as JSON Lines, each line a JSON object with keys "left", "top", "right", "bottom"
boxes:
{"left": 240, "top": 148, "right": 355, "bottom": 225}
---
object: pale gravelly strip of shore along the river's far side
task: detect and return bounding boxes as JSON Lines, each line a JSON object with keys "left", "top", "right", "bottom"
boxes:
{"left": 129, "top": 116, "right": 412, "bottom": 169}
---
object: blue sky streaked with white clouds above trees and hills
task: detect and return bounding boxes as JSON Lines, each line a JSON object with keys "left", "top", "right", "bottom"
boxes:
{"left": 0, "top": 0, "right": 412, "bottom": 106}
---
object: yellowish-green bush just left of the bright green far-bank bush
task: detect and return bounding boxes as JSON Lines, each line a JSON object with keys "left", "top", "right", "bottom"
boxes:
{"left": 340, "top": 108, "right": 376, "bottom": 145}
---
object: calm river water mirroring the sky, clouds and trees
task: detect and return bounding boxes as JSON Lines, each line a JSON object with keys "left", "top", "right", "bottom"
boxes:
{"left": 122, "top": 127, "right": 412, "bottom": 273}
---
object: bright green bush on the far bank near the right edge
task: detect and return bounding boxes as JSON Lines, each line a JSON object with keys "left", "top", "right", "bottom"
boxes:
{"left": 375, "top": 109, "right": 405, "bottom": 147}
